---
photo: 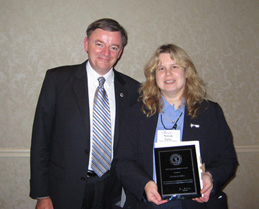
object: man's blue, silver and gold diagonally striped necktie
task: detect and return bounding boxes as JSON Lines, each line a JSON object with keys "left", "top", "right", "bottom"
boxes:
{"left": 91, "top": 77, "right": 112, "bottom": 177}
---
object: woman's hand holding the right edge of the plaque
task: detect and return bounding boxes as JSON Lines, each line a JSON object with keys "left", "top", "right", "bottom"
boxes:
{"left": 193, "top": 172, "right": 213, "bottom": 203}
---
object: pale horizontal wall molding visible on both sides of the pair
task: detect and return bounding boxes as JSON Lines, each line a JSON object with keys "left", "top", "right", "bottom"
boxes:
{"left": 0, "top": 145, "right": 259, "bottom": 158}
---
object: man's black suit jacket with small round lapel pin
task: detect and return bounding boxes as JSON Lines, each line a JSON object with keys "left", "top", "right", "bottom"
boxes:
{"left": 30, "top": 59, "right": 139, "bottom": 209}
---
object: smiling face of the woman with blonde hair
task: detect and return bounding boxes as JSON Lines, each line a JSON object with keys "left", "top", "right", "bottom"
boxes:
{"left": 156, "top": 53, "right": 187, "bottom": 98}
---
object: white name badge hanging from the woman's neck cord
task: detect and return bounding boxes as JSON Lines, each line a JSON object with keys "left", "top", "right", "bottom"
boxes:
{"left": 157, "top": 130, "right": 181, "bottom": 143}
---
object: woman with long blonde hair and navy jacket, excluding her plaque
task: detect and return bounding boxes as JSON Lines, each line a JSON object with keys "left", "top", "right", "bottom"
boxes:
{"left": 115, "top": 44, "right": 238, "bottom": 209}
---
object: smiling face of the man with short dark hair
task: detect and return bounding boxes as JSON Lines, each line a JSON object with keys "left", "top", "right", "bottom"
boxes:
{"left": 85, "top": 28, "right": 123, "bottom": 75}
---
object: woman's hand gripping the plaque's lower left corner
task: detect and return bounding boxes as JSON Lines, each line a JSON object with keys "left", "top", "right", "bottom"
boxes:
{"left": 145, "top": 181, "right": 167, "bottom": 205}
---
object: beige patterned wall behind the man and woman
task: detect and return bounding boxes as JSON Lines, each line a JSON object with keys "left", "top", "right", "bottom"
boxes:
{"left": 0, "top": 0, "right": 259, "bottom": 209}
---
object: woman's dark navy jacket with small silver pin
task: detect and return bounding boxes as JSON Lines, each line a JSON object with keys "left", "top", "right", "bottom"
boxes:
{"left": 116, "top": 101, "right": 238, "bottom": 209}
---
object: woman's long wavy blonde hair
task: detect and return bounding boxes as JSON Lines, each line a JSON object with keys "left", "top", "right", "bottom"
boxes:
{"left": 139, "top": 44, "right": 206, "bottom": 118}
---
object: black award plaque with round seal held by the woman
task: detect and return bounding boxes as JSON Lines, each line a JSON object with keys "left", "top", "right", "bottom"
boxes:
{"left": 155, "top": 144, "right": 201, "bottom": 199}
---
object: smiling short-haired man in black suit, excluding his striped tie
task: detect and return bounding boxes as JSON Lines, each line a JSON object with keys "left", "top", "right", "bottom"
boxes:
{"left": 30, "top": 19, "right": 139, "bottom": 209}
